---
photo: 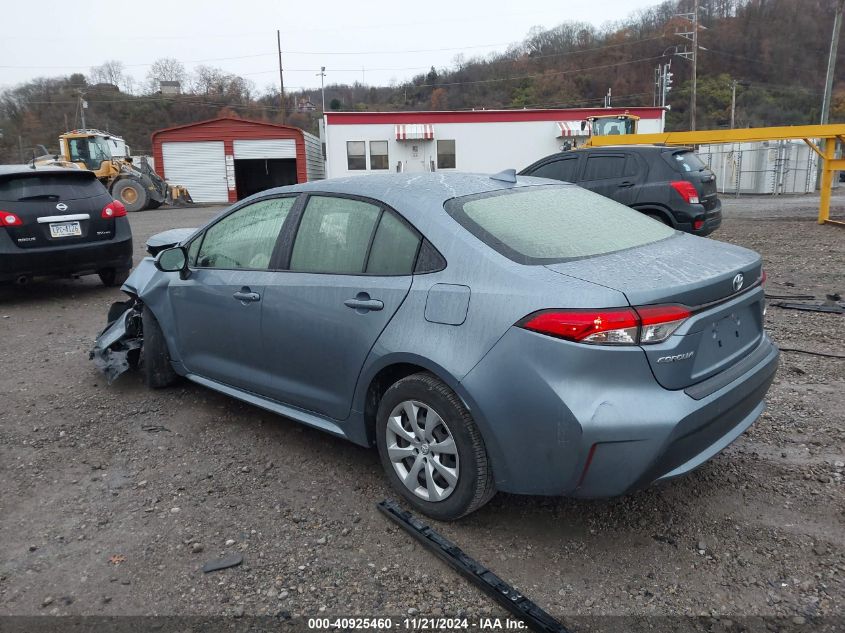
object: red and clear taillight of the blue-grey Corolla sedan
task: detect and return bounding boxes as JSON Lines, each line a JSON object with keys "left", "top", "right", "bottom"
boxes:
{"left": 518, "top": 305, "right": 692, "bottom": 345}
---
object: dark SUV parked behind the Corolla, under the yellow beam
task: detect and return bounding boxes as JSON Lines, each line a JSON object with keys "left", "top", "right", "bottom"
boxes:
{"left": 519, "top": 145, "right": 722, "bottom": 235}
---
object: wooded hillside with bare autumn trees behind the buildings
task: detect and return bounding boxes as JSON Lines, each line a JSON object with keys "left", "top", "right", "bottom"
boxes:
{"left": 0, "top": 0, "right": 845, "bottom": 163}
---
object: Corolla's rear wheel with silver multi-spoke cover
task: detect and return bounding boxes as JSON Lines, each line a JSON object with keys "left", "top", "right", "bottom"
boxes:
{"left": 376, "top": 372, "right": 496, "bottom": 521}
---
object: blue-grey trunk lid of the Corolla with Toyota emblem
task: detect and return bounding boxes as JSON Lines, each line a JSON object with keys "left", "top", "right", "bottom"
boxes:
{"left": 548, "top": 233, "right": 764, "bottom": 389}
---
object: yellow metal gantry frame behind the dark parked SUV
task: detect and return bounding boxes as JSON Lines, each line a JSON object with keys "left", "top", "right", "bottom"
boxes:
{"left": 585, "top": 124, "right": 845, "bottom": 226}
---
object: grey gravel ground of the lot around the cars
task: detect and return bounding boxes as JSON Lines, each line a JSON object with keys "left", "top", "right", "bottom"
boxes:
{"left": 0, "top": 196, "right": 845, "bottom": 624}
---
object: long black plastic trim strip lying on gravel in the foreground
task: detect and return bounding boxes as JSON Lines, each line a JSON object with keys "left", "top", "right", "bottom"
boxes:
{"left": 377, "top": 500, "right": 567, "bottom": 633}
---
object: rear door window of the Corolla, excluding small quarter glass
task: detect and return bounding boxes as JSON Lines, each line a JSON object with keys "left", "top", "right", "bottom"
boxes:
{"left": 290, "top": 196, "right": 381, "bottom": 275}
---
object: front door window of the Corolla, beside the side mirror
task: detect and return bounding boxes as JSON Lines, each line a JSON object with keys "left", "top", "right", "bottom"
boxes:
{"left": 192, "top": 197, "right": 296, "bottom": 270}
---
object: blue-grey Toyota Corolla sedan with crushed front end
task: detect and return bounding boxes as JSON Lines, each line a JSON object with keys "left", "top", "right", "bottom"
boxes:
{"left": 92, "top": 172, "right": 778, "bottom": 519}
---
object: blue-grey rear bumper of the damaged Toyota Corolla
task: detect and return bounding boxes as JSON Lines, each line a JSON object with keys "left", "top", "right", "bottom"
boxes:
{"left": 461, "top": 328, "right": 779, "bottom": 498}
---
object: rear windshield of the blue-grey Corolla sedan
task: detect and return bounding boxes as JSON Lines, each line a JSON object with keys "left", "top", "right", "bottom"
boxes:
{"left": 446, "top": 185, "right": 675, "bottom": 264}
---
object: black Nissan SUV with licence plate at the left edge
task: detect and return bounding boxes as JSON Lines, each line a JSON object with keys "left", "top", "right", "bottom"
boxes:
{"left": 0, "top": 165, "right": 132, "bottom": 286}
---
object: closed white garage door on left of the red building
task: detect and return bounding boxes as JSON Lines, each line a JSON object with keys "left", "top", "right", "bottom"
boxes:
{"left": 161, "top": 141, "right": 229, "bottom": 202}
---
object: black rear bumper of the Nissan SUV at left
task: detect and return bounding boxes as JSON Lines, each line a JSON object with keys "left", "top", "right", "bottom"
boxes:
{"left": 0, "top": 218, "right": 132, "bottom": 281}
